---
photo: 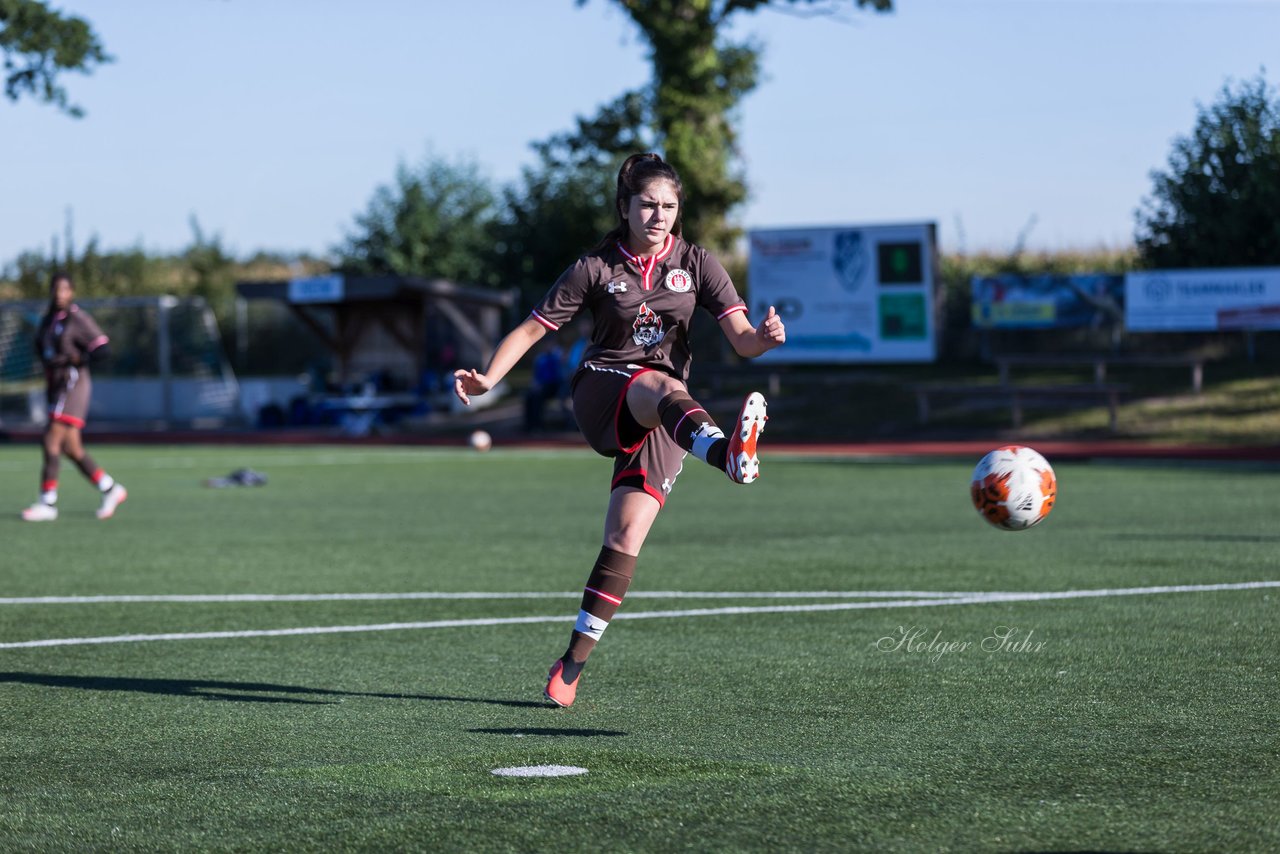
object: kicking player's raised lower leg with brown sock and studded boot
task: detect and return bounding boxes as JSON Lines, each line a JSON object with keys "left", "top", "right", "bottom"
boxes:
{"left": 658, "top": 389, "right": 768, "bottom": 484}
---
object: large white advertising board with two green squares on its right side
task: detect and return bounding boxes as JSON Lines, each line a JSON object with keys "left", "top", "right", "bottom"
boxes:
{"left": 748, "top": 223, "right": 937, "bottom": 364}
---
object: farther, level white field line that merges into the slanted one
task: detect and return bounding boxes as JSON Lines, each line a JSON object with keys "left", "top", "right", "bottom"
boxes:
{"left": 0, "top": 590, "right": 972, "bottom": 606}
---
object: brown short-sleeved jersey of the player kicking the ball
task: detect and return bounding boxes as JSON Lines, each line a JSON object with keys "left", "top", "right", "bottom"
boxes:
{"left": 532, "top": 234, "right": 746, "bottom": 382}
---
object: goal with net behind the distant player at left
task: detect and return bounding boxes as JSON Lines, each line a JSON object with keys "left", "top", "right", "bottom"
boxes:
{"left": 0, "top": 296, "right": 241, "bottom": 428}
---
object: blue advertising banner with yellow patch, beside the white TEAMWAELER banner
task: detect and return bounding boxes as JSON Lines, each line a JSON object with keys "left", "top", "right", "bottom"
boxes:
{"left": 970, "top": 273, "right": 1124, "bottom": 329}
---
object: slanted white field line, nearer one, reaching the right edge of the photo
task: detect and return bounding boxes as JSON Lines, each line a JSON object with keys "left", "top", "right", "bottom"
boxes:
{"left": 0, "top": 581, "right": 1280, "bottom": 649}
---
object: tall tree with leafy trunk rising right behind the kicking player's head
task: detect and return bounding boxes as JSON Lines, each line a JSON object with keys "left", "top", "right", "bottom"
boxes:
{"left": 577, "top": 0, "right": 893, "bottom": 250}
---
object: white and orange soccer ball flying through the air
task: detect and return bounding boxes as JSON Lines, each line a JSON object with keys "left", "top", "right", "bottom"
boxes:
{"left": 969, "top": 444, "right": 1057, "bottom": 531}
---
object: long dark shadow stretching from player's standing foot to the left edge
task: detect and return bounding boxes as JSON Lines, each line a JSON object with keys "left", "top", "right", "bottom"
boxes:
{"left": 0, "top": 673, "right": 548, "bottom": 708}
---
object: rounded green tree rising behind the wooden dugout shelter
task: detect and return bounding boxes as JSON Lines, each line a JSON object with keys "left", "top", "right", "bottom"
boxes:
{"left": 335, "top": 156, "right": 499, "bottom": 286}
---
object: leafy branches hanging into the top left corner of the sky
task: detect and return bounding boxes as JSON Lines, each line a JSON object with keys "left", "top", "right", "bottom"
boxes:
{"left": 0, "top": 0, "right": 111, "bottom": 118}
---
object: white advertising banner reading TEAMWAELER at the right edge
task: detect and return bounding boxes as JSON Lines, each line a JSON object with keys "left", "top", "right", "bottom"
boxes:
{"left": 1125, "top": 266, "right": 1280, "bottom": 332}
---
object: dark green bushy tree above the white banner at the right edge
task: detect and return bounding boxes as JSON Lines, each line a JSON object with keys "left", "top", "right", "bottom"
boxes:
{"left": 1137, "top": 73, "right": 1280, "bottom": 268}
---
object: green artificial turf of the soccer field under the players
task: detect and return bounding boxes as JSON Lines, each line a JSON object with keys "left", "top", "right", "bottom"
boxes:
{"left": 0, "top": 446, "right": 1280, "bottom": 851}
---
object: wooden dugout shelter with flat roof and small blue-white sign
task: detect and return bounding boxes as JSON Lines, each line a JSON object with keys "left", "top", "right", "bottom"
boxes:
{"left": 236, "top": 274, "right": 518, "bottom": 384}
